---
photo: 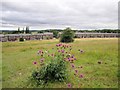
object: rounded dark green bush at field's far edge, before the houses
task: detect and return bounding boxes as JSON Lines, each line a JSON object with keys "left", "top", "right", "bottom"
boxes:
{"left": 60, "top": 28, "right": 74, "bottom": 43}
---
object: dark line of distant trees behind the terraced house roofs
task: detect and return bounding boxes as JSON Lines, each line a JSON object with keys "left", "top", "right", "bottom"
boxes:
{"left": 1, "top": 26, "right": 120, "bottom": 34}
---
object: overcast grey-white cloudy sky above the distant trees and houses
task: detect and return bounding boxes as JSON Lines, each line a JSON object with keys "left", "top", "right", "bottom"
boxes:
{"left": 0, "top": 0, "right": 119, "bottom": 30}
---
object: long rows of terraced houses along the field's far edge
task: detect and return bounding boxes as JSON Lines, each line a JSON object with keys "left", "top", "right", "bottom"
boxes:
{"left": 0, "top": 32, "right": 119, "bottom": 42}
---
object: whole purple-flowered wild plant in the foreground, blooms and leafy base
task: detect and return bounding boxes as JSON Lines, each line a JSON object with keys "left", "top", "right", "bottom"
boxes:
{"left": 32, "top": 43, "right": 84, "bottom": 87}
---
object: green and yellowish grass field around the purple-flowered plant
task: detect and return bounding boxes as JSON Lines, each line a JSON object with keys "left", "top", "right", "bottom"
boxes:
{"left": 2, "top": 38, "right": 118, "bottom": 88}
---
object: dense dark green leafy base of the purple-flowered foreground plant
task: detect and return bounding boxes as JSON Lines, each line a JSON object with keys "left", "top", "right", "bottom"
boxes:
{"left": 32, "top": 56, "right": 67, "bottom": 85}
